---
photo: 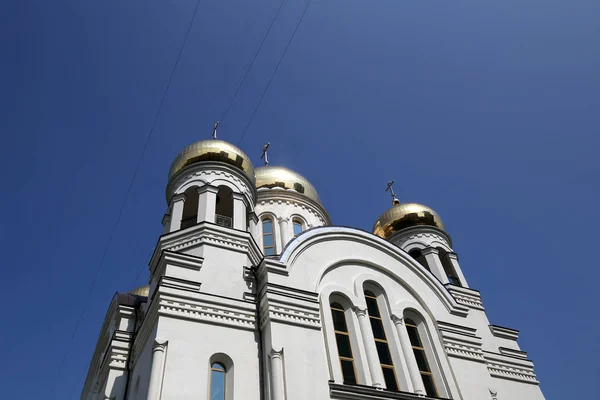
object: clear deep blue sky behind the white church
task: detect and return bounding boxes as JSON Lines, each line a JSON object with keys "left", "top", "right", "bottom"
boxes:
{"left": 0, "top": 0, "right": 600, "bottom": 399}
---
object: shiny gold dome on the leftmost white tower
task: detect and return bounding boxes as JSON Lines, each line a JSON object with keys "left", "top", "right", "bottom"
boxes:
{"left": 169, "top": 139, "right": 254, "bottom": 182}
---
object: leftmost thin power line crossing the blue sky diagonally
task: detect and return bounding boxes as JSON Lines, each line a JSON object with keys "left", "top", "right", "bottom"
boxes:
{"left": 49, "top": 0, "right": 200, "bottom": 397}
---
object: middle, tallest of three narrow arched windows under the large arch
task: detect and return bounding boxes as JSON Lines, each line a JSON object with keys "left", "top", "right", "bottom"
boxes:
{"left": 365, "top": 290, "right": 398, "bottom": 391}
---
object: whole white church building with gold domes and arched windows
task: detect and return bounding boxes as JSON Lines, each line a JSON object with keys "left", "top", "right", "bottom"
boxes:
{"left": 81, "top": 139, "right": 544, "bottom": 400}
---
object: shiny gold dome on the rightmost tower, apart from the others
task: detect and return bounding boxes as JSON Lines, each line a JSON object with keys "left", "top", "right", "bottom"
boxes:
{"left": 373, "top": 203, "right": 444, "bottom": 239}
